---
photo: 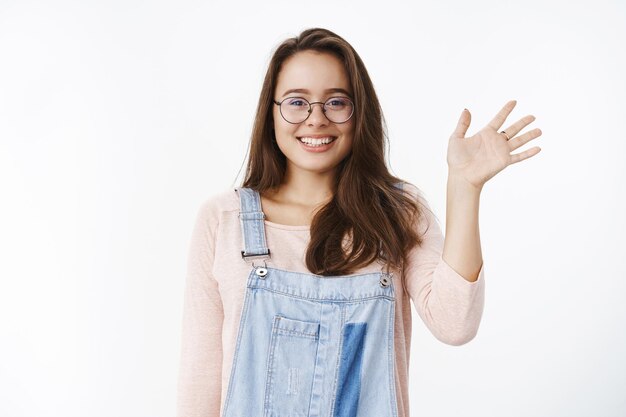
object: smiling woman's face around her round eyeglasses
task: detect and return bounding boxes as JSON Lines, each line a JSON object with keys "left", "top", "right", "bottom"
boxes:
{"left": 273, "top": 51, "right": 354, "bottom": 173}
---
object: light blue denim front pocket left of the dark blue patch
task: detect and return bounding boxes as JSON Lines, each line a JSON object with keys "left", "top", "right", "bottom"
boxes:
{"left": 265, "top": 315, "right": 320, "bottom": 417}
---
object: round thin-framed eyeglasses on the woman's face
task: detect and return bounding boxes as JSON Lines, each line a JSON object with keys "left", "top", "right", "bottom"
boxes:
{"left": 274, "top": 97, "right": 354, "bottom": 124}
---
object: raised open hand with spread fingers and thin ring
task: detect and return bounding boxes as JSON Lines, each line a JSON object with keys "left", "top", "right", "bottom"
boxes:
{"left": 447, "top": 100, "right": 541, "bottom": 189}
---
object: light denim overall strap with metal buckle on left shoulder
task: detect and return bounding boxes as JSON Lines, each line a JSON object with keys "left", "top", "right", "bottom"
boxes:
{"left": 235, "top": 187, "right": 270, "bottom": 260}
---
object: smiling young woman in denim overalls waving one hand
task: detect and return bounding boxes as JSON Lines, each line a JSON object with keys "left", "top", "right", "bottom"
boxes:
{"left": 178, "top": 28, "right": 541, "bottom": 417}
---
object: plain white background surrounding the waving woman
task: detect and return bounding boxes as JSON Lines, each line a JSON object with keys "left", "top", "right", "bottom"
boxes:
{"left": 0, "top": 0, "right": 626, "bottom": 417}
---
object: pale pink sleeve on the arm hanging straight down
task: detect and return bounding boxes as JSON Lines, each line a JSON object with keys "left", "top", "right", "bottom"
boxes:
{"left": 176, "top": 201, "right": 224, "bottom": 417}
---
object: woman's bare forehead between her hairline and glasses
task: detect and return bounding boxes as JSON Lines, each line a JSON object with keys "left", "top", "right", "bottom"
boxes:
{"left": 276, "top": 51, "right": 351, "bottom": 97}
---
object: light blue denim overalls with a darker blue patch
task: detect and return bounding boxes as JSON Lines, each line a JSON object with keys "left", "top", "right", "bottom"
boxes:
{"left": 222, "top": 188, "right": 398, "bottom": 417}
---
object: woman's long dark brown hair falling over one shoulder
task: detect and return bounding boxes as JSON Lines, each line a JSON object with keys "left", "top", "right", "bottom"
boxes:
{"left": 242, "top": 28, "right": 422, "bottom": 276}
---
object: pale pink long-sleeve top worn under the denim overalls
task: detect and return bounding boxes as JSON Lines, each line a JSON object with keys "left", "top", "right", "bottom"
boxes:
{"left": 177, "top": 183, "right": 485, "bottom": 417}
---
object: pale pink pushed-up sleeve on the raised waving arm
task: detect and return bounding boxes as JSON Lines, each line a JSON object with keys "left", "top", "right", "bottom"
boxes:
{"left": 404, "top": 184, "right": 485, "bottom": 346}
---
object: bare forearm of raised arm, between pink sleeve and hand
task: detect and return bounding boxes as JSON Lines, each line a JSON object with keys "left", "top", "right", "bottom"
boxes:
{"left": 442, "top": 173, "right": 483, "bottom": 282}
